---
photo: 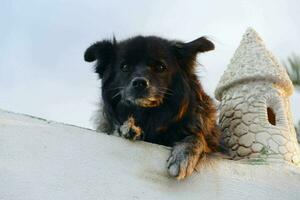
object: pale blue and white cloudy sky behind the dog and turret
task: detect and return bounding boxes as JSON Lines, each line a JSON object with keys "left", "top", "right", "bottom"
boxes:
{"left": 0, "top": 0, "right": 300, "bottom": 127}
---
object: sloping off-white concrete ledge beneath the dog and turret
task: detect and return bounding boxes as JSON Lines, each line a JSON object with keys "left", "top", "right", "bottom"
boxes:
{"left": 0, "top": 110, "right": 300, "bottom": 200}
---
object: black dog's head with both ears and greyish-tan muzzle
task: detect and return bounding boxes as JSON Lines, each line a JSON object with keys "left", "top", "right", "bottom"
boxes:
{"left": 84, "top": 36, "right": 214, "bottom": 107}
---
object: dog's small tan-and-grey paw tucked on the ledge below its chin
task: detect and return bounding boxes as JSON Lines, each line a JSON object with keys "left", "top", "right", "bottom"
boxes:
{"left": 119, "top": 117, "right": 142, "bottom": 140}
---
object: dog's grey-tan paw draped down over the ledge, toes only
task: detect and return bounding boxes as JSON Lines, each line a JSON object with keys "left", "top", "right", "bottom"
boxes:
{"left": 167, "top": 143, "right": 202, "bottom": 180}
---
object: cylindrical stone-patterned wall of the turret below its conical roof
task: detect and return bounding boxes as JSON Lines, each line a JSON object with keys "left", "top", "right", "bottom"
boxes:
{"left": 219, "top": 81, "right": 300, "bottom": 164}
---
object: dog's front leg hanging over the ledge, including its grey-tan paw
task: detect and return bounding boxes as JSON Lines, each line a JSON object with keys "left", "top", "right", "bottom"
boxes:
{"left": 167, "top": 135, "right": 208, "bottom": 180}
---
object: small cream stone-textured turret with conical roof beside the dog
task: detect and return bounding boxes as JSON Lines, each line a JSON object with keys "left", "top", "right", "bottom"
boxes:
{"left": 215, "top": 28, "right": 300, "bottom": 164}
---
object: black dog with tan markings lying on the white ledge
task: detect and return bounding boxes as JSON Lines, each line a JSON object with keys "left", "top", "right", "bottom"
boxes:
{"left": 84, "top": 36, "right": 219, "bottom": 179}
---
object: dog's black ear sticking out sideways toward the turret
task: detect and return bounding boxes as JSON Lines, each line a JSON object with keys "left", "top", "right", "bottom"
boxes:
{"left": 174, "top": 37, "right": 215, "bottom": 69}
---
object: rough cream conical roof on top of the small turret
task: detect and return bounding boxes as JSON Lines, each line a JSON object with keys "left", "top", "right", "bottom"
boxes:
{"left": 215, "top": 28, "right": 294, "bottom": 100}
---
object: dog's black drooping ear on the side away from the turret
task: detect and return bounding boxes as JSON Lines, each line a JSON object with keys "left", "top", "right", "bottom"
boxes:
{"left": 84, "top": 38, "right": 117, "bottom": 78}
